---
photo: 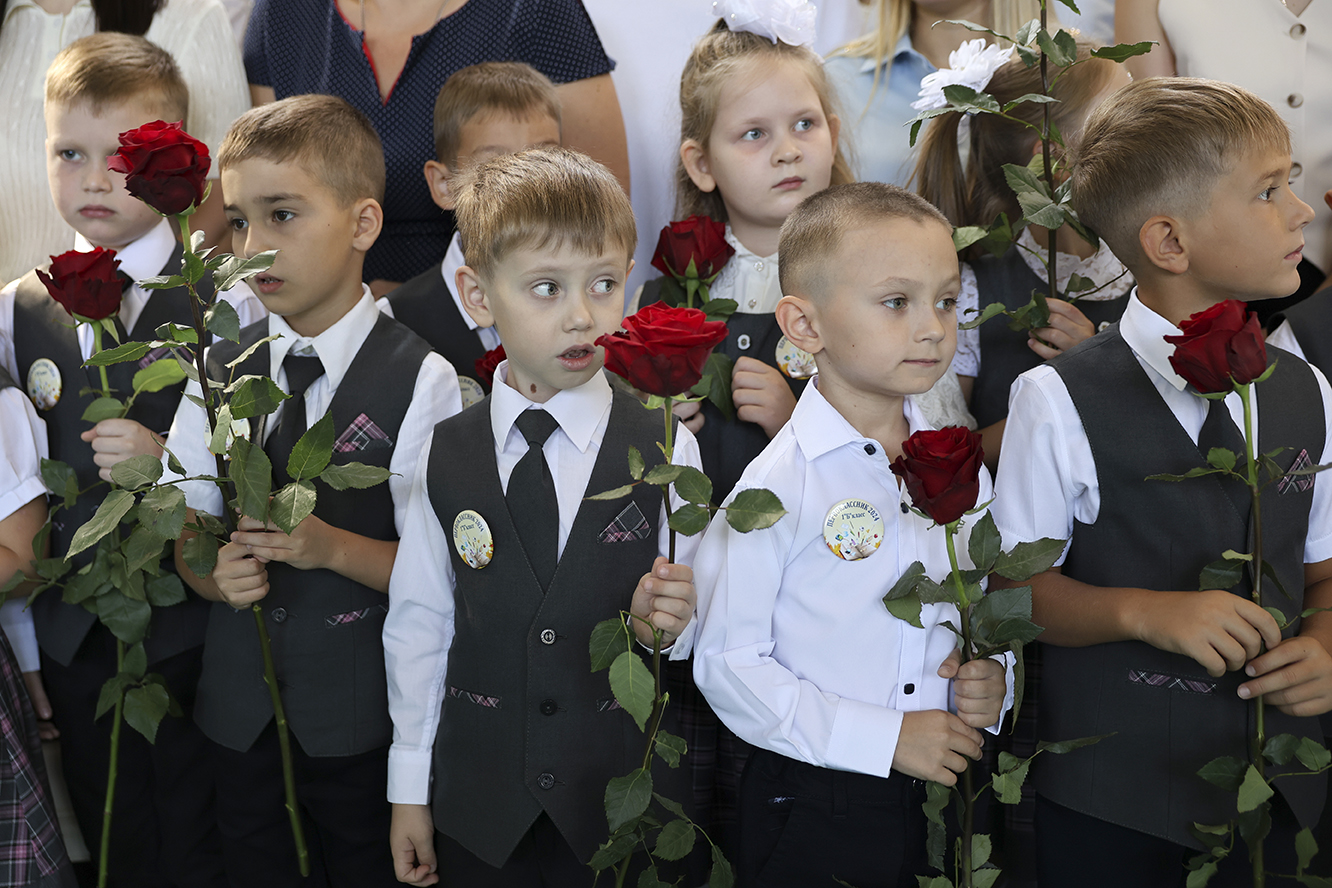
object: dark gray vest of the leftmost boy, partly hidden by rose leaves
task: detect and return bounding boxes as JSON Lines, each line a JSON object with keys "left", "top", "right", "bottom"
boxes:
{"left": 13, "top": 245, "right": 210, "bottom": 666}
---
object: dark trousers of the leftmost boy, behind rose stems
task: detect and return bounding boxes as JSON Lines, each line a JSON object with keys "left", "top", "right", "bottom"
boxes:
{"left": 41, "top": 623, "right": 226, "bottom": 888}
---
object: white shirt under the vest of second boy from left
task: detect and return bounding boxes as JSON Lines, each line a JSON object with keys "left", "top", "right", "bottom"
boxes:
{"left": 163, "top": 285, "right": 462, "bottom": 534}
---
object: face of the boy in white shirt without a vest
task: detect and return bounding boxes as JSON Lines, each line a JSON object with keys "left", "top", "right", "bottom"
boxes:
{"left": 810, "top": 218, "right": 960, "bottom": 398}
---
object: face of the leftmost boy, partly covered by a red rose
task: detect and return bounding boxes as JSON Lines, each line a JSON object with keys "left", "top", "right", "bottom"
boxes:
{"left": 45, "top": 99, "right": 169, "bottom": 249}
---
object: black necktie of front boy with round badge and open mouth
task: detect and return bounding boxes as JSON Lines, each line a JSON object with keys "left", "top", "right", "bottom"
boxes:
{"left": 505, "top": 410, "right": 559, "bottom": 591}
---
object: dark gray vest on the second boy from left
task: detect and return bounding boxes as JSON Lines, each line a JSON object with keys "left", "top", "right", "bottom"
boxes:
{"left": 194, "top": 314, "right": 430, "bottom": 756}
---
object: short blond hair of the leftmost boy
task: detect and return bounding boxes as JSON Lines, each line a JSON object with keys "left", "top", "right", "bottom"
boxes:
{"left": 45, "top": 31, "right": 189, "bottom": 124}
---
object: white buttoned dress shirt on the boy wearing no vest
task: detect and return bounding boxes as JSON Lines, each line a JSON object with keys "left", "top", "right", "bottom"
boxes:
{"left": 694, "top": 377, "right": 1011, "bottom": 776}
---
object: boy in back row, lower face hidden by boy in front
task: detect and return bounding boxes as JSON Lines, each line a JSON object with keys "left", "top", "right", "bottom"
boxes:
{"left": 380, "top": 61, "right": 559, "bottom": 407}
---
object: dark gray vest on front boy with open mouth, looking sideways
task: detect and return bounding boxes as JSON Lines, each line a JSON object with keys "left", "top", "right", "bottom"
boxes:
{"left": 428, "top": 393, "right": 689, "bottom": 867}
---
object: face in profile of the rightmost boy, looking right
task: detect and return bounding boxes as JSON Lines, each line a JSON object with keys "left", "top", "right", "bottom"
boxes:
{"left": 1187, "top": 144, "right": 1313, "bottom": 301}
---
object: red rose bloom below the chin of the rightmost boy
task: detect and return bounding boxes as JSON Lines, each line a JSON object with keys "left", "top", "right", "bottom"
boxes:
{"left": 1166, "top": 300, "right": 1267, "bottom": 394}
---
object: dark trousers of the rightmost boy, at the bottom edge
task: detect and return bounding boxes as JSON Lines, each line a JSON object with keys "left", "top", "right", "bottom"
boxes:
{"left": 1036, "top": 795, "right": 1300, "bottom": 888}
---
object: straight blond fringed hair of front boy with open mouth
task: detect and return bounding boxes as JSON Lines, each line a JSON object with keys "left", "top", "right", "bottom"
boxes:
{"left": 456, "top": 148, "right": 638, "bottom": 276}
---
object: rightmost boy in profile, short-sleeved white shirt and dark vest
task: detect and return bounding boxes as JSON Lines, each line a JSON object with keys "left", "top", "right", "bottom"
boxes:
{"left": 994, "top": 79, "right": 1332, "bottom": 888}
